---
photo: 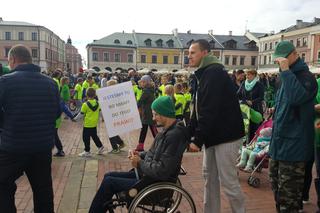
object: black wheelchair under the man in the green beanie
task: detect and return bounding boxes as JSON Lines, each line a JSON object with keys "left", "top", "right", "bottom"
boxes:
{"left": 105, "top": 167, "right": 196, "bottom": 213}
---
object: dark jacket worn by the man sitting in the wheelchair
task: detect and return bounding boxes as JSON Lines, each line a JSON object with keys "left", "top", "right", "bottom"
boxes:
{"left": 138, "top": 124, "right": 190, "bottom": 181}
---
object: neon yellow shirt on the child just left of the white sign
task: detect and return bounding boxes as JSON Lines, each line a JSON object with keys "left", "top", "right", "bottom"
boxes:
{"left": 81, "top": 99, "right": 100, "bottom": 128}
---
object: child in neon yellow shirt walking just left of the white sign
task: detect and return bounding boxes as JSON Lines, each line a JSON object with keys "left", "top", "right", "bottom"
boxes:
{"left": 76, "top": 87, "right": 104, "bottom": 157}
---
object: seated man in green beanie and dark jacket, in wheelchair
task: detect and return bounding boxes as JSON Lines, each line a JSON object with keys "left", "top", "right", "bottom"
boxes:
{"left": 89, "top": 96, "right": 189, "bottom": 213}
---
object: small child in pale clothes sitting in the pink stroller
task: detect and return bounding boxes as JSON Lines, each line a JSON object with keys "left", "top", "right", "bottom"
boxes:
{"left": 237, "top": 127, "right": 272, "bottom": 172}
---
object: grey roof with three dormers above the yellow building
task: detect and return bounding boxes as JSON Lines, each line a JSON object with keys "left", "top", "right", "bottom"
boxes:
{"left": 135, "top": 33, "right": 182, "bottom": 49}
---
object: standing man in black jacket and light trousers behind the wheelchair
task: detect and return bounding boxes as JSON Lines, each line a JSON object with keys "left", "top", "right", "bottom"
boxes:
{"left": 189, "top": 39, "right": 245, "bottom": 213}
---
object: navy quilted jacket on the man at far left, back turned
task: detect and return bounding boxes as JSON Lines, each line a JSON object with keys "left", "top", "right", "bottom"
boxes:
{"left": 0, "top": 64, "right": 61, "bottom": 153}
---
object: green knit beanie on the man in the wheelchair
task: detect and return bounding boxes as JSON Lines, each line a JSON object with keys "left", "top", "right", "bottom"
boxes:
{"left": 151, "top": 96, "right": 176, "bottom": 118}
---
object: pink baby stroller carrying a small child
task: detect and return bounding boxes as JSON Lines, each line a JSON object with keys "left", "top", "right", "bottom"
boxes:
{"left": 246, "top": 118, "right": 272, "bottom": 188}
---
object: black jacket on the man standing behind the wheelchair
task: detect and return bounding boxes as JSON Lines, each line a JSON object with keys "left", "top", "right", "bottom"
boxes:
{"left": 191, "top": 64, "right": 244, "bottom": 148}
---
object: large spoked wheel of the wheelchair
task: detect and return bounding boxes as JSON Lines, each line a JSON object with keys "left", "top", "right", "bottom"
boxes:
{"left": 128, "top": 182, "right": 196, "bottom": 213}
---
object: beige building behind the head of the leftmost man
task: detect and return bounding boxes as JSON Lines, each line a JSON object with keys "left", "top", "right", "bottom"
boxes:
{"left": 0, "top": 18, "right": 65, "bottom": 71}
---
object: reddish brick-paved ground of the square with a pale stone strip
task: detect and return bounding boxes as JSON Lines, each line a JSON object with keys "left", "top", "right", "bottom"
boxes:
{"left": 14, "top": 120, "right": 316, "bottom": 213}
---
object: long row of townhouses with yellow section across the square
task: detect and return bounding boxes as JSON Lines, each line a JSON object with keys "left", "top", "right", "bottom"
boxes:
{"left": 87, "top": 29, "right": 258, "bottom": 71}
